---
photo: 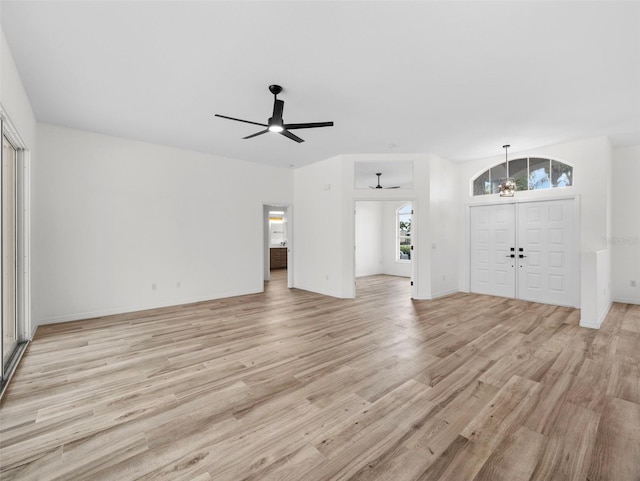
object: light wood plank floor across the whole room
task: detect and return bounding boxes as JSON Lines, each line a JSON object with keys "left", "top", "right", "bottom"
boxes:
{"left": 0, "top": 271, "right": 640, "bottom": 481}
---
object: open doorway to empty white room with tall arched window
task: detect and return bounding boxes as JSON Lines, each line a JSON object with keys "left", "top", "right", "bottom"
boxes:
{"left": 355, "top": 200, "right": 414, "bottom": 297}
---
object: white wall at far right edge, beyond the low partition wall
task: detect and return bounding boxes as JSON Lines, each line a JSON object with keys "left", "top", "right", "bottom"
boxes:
{"left": 609, "top": 146, "right": 640, "bottom": 304}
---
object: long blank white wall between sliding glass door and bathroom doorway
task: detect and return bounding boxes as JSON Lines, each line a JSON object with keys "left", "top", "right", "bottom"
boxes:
{"left": 32, "top": 124, "right": 292, "bottom": 323}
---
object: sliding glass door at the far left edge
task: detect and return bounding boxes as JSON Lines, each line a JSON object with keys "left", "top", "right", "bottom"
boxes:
{"left": 1, "top": 135, "right": 18, "bottom": 378}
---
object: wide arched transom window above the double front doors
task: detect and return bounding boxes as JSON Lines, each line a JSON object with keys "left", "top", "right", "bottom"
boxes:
{"left": 473, "top": 157, "right": 573, "bottom": 195}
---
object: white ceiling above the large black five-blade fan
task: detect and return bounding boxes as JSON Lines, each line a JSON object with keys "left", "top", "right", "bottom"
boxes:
{"left": 0, "top": 0, "right": 640, "bottom": 167}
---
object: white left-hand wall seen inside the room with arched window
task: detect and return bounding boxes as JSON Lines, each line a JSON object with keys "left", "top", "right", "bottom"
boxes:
{"left": 355, "top": 201, "right": 382, "bottom": 277}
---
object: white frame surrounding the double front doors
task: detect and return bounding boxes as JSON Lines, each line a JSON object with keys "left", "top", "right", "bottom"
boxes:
{"left": 465, "top": 194, "right": 581, "bottom": 309}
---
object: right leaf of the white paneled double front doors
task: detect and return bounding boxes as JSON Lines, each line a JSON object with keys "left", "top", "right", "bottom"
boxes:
{"left": 517, "top": 199, "right": 578, "bottom": 306}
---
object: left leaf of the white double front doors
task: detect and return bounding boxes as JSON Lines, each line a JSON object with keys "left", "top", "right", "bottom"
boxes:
{"left": 470, "top": 204, "right": 516, "bottom": 297}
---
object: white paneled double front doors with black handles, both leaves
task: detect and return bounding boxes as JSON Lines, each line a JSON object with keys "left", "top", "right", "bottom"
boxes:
{"left": 470, "top": 199, "right": 578, "bottom": 307}
